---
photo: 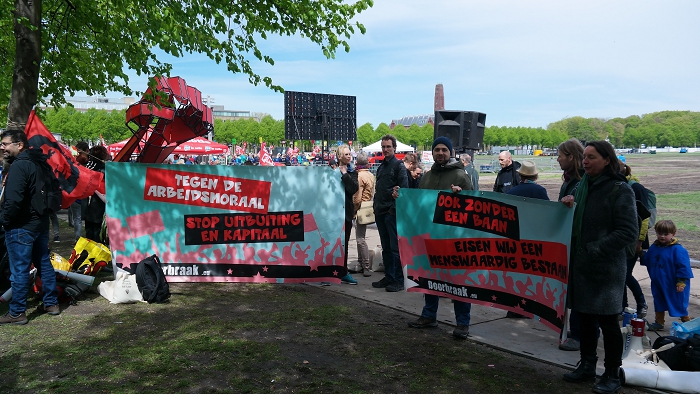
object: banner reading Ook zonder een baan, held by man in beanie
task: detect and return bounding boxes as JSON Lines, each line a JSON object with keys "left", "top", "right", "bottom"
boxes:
{"left": 396, "top": 189, "right": 574, "bottom": 332}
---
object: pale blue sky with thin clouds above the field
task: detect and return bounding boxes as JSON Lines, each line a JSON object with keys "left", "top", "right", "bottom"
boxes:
{"left": 123, "top": 0, "right": 700, "bottom": 127}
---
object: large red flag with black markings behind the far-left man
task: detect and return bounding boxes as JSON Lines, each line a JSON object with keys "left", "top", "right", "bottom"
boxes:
{"left": 24, "top": 110, "right": 105, "bottom": 208}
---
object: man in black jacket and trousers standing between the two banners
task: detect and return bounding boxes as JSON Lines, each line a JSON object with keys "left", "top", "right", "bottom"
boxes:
{"left": 372, "top": 134, "right": 408, "bottom": 292}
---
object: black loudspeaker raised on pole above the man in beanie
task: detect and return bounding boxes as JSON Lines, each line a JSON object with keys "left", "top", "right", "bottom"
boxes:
{"left": 433, "top": 111, "right": 486, "bottom": 153}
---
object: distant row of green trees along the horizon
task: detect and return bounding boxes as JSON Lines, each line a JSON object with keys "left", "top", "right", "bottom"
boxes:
{"left": 41, "top": 107, "right": 700, "bottom": 150}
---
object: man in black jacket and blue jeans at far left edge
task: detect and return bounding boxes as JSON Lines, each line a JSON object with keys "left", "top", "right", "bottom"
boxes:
{"left": 0, "top": 130, "right": 61, "bottom": 324}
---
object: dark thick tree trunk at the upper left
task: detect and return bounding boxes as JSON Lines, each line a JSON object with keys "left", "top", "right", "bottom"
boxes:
{"left": 7, "top": 0, "right": 42, "bottom": 130}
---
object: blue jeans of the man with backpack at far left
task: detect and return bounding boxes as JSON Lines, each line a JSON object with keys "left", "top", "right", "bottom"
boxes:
{"left": 5, "top": 228, "right": 58, "bottom": 316}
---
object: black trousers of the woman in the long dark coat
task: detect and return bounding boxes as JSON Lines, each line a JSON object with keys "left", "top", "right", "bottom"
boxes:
{"left": 579, "top": 312, "right": 623, "bottom": 371}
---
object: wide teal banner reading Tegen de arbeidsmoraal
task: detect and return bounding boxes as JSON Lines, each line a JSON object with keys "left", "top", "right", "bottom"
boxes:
{"left": 105, "top": 163, "right": 346, "bottom": 283}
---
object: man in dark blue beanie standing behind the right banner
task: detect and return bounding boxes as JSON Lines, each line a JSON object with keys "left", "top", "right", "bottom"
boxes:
{"left": 408, "top": 137, "right": 474, "bottom": 339}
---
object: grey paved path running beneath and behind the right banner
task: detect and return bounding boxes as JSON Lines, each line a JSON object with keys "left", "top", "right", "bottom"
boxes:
{"left": 312, "top": 225, "right": 700, "bottom": 374}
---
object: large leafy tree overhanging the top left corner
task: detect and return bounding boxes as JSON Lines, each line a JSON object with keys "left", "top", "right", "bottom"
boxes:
{"left": 0, "top": 0, "right": 373, "bottom": 128}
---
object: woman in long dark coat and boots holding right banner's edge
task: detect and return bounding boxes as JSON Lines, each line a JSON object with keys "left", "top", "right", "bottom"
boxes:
{"left": 561, "top": 141, "right": 639, "bottom": 393}
